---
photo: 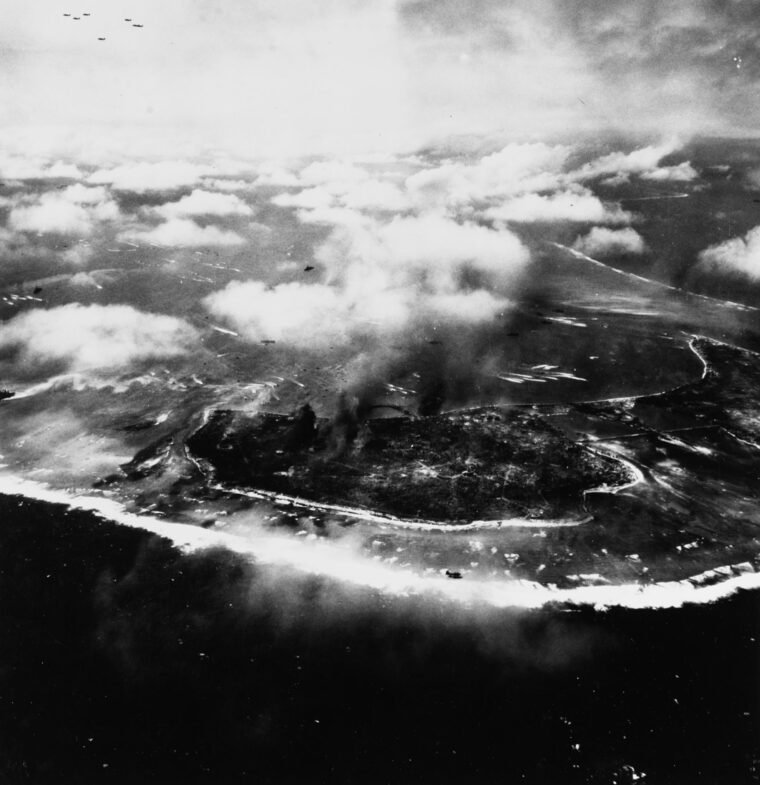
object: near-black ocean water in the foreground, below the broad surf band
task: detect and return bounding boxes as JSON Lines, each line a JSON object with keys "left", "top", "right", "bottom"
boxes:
{"left": 0, "top": 496, "right": 760, "bottom": 785}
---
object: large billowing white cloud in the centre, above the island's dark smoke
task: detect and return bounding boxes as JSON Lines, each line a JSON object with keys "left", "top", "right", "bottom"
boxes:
{"left": 204, "top": 213, "right": 529, "bottom": 349}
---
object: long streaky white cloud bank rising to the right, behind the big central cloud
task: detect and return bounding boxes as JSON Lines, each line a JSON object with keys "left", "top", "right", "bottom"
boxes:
{"left": 272, "top": 139, "right": 697, "bottom": 223}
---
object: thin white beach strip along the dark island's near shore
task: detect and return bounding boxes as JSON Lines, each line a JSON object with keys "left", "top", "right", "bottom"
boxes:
{"left": 210, "top": 483, "right": 592, "bottom": 532}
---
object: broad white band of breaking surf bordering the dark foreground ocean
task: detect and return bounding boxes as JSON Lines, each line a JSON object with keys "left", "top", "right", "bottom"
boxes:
{"left": 0, "top": 473, "right": 760, "bottom": 610}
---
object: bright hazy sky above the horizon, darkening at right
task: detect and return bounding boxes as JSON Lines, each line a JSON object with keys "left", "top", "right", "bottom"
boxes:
{"left": 0, "top": 0, "right": 760, "bottom": 157}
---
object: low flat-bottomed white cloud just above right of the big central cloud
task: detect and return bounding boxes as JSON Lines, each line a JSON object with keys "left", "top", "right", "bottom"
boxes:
{"left": 485, "top": 190, "right": 633, "bottom": 224}
